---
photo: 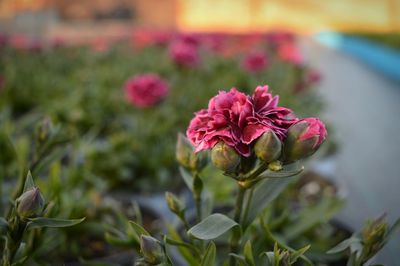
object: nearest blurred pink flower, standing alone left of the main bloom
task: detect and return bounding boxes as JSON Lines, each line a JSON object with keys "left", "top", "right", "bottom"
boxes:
{"left": 125, "top": 74, "right": 169, "bottom": 107}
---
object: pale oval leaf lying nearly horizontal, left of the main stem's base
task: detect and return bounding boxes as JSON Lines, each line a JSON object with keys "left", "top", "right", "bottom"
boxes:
{"left": 188, "top": 213, "right": 239, "bottom": 240}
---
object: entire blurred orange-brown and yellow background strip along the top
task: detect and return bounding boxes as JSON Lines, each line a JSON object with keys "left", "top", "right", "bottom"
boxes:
{"left": 0, "top": 0, "right": 400, "bottom": 34}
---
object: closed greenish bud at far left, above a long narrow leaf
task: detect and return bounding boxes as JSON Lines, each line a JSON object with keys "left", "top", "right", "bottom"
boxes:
{"left": 17, "top": 187, "right": 44, "bottom": 219}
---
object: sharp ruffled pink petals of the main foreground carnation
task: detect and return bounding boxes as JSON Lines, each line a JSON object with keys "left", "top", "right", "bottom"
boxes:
{"left": 186, "top": 86, "right": 298, "bottom": 157}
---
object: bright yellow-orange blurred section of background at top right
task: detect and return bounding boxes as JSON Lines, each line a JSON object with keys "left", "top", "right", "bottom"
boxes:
{"left": 177, "top": 0, "right": 400, "bottom": 33}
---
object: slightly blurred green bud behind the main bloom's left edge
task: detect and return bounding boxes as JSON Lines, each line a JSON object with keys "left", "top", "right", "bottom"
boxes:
{"left": 175, "top": 133, "right": 207, "bottom": 171}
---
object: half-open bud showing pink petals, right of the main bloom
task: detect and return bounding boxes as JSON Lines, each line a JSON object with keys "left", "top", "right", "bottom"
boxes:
{"left": 284, "top": 118, "right": 327, "bottom": 163}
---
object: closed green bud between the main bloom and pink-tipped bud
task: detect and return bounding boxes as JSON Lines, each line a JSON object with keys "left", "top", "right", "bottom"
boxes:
{"left": 254, "top": 130, "right": 282, "bottom": 163}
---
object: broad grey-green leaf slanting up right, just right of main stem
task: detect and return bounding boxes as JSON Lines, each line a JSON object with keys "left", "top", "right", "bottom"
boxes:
{"left": 243, "top": 178, "right": 292, "bottom": 228}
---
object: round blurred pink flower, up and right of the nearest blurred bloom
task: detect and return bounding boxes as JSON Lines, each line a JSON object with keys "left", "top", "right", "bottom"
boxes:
{"left": 169, "top": 41, "right": 200, "bottom": 67}
